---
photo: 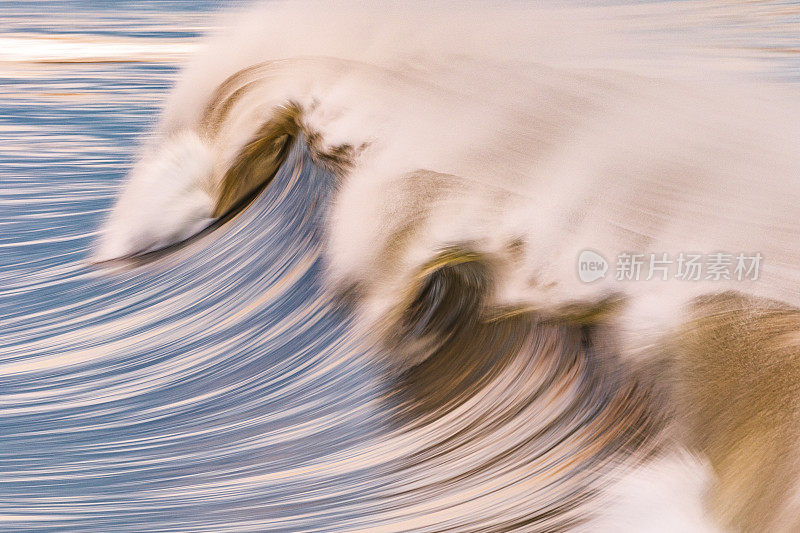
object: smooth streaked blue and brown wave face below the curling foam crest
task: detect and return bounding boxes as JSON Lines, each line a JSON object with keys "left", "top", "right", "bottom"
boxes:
{"left": 2, "top": 136, "right": 658, "bottom": 531}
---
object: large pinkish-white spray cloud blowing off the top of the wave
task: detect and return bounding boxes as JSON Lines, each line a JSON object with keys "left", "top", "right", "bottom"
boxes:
{"left": 98, "top": 2, "right": 800, "bottom": 351}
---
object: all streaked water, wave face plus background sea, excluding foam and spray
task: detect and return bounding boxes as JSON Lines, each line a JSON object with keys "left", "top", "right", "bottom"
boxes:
{"left": 0, "top": 0, "right": 800, "bottom": 532}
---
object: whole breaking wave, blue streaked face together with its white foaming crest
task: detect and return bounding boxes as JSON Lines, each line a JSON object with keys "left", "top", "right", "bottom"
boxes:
{"left": 0, "top": 0, "right": 800, "bottom": 532}
